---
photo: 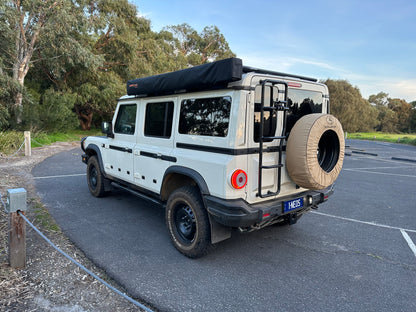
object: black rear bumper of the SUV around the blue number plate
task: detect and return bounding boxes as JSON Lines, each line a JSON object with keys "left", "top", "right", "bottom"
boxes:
{"left": 204, "top": 185, "right": 334, "bottom": 228}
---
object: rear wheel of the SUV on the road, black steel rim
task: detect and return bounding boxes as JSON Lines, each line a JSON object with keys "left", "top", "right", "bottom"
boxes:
{"left": 166, "top": 186, "right": 211, "bottom": 258}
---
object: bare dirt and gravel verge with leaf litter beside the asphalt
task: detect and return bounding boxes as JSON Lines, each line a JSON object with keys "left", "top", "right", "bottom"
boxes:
{"left": 0, "top": 142, "right": 150, "bottom": 312}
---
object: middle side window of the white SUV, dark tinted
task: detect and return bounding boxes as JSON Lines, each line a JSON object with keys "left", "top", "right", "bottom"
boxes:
{"left": 144, "top": 102, "right": 173, "bottom": 139}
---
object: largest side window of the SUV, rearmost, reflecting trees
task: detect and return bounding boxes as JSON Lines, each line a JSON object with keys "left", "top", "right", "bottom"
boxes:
{"left": 179, "top": 96, "right": 231, "bottom": 137}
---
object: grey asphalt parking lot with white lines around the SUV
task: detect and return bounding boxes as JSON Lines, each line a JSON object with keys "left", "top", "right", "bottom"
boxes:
{"left": 32, "top": 140, "right": 416, "bottom": 311}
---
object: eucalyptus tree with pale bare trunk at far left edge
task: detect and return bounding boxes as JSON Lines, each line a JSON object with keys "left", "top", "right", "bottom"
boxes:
{"left": 0, "top": 0, "right": 91, "bottom": 124}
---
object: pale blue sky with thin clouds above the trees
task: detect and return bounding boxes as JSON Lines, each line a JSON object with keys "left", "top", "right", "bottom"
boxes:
{"left": 130, "top": 0, "right": 416, "bottom": 102}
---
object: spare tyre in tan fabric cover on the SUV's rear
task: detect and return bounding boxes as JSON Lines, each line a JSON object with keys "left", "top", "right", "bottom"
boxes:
{"left": 286, "top": 114, "right": 345, "bottom": 190}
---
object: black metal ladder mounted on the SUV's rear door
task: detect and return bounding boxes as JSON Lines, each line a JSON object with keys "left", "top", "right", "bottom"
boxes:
{"left": 257, "top": 79, "right": 289, "bottom": 198}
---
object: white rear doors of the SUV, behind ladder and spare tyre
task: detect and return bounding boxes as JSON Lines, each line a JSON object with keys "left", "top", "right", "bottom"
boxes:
{"left": 247, "top": 76, "right": 328, "bottom": 203}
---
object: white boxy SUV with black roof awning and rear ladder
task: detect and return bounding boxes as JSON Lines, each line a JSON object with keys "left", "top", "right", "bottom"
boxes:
{"left": 81, "top": 58, "right": 345, "bottom": 258}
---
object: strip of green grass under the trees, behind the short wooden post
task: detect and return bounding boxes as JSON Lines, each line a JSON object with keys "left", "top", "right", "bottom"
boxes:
{"left": 0, "top": 129, "right": 101, "bottom": 156}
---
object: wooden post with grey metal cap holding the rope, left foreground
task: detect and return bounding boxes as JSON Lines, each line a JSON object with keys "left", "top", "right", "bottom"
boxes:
{"left": 6, "top": 188, "right": 26, "bottom": 268}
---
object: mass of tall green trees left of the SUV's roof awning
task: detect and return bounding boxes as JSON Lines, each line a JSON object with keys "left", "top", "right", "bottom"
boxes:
{"left": 0, "top": 0, "right": 234, "bottom": 130}
